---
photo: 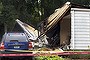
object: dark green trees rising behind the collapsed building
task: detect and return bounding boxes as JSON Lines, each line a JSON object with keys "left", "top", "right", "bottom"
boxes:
{"left": 0, "top": 0, "right": 90, "bottom": 31}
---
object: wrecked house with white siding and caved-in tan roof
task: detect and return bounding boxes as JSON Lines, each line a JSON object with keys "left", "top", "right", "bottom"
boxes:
{"left": 40, "top": 2, "right": 90, "bottom": 49}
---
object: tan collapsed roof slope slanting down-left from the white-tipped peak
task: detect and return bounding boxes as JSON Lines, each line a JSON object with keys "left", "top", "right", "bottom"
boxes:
{"left": 46, "top": 2, "right": 71, "bottom": 31}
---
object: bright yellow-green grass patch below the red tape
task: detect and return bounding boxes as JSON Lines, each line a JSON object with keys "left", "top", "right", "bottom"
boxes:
{"left": 33, "top": 56, "right": 64, "bottom": 60}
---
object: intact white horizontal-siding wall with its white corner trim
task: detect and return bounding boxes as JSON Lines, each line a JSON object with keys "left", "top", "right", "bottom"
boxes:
{"left": 71, "top": 8, "right": 90, "bottom": 49}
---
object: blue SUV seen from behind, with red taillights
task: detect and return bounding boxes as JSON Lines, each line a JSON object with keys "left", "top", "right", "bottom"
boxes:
{"left": 1, "top": 33, "right": 32, "bottom": 50}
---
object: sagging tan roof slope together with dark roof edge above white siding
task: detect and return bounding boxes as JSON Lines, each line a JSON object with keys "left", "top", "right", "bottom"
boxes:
{"left": 45, "top": 2, "right": 90, "bottom": 32}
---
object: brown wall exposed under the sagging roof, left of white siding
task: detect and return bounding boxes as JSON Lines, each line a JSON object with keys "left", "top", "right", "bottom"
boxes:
{"left": 60, "top": 15, "right": 71, "bottom": 45}
